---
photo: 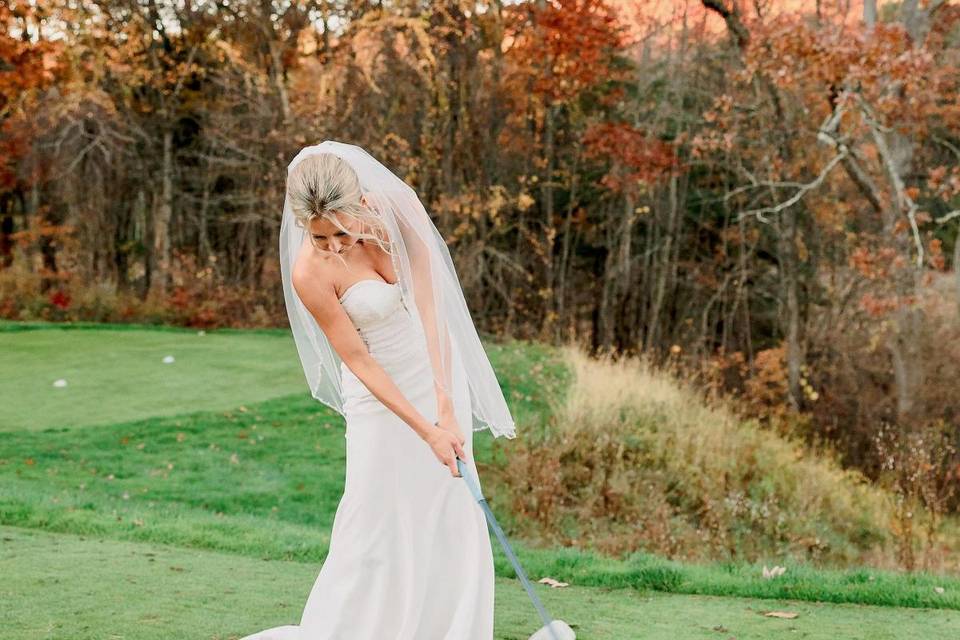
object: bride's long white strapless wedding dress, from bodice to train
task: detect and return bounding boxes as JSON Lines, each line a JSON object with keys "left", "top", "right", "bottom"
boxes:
{"left": 242, "top": 279, "right": 494, "bottom": 640}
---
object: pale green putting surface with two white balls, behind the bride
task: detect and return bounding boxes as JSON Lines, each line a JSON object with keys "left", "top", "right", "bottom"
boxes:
{"left": 0, "top": 322, "right": 305, "bottom": 431}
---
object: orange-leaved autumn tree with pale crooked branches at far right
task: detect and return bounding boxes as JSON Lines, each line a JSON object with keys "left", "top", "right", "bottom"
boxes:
{"left": 695, "top": 1, "right": 960, "bottom": 470}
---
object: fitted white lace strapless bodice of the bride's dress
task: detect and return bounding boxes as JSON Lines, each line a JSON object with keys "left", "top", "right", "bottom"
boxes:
{"left": 340, "top": 278, "right": 432, "bottom": 411}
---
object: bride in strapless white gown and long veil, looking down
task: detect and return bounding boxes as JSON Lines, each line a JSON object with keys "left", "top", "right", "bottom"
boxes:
{"left": 242, "top": 140, "right": 516, "bottom": 640}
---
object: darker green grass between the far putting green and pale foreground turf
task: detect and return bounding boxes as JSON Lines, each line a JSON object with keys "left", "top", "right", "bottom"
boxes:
{"left": 0, "top": 394, "right": 960, "bottom": 609}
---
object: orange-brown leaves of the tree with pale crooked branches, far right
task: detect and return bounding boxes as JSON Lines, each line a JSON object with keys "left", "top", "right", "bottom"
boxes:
{"left": 691, "top": 7, "right": 960, "bottom": 330}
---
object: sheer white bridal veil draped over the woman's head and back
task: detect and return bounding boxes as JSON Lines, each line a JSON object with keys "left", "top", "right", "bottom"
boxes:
{"left": 280, "top": 140, "right": 516, "bottom": 438}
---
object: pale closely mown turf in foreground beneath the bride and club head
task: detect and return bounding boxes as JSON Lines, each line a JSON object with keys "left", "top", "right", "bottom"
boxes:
{"left": 7, "top": 527, "right": 960, "bottom": 640}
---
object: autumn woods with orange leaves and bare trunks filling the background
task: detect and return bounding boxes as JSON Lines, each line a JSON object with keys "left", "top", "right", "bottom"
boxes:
{"left": 0, "top": 0, "right": 960, "bottom": 524}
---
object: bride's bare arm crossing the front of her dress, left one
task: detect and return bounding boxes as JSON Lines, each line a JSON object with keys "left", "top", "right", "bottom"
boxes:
{"left": 292, "top": 270, "right": 466, "bottom": 476}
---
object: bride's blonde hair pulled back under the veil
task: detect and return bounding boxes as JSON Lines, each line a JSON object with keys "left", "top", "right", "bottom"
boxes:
{"left": 287, "top": 153, "right": 391, "bottom": 261}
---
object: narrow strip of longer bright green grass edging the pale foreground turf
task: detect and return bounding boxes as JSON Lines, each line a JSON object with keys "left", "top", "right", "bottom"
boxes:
{"left": 7, "top": 484, "right": 960, "bottom": 610}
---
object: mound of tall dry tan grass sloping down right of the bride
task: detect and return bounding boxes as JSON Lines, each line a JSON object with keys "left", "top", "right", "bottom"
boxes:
{"left": 502, "top": 346, "right": 948, "bottom": 566}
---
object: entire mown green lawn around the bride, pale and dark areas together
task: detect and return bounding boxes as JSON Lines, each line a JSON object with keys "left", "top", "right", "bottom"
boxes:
{"left": 0, "top": 325, "right": 960, "bottom": 639}
